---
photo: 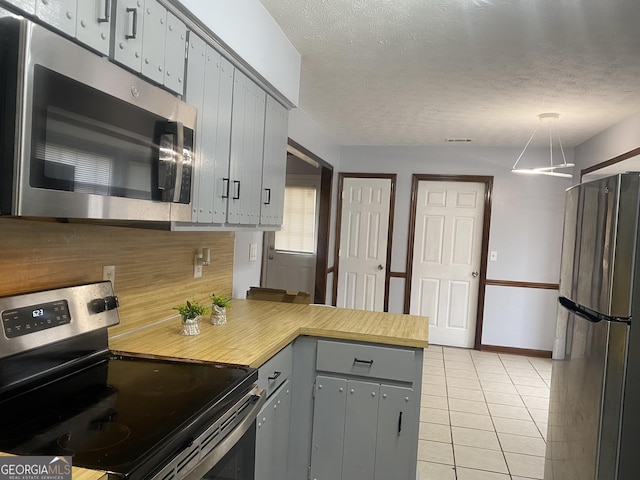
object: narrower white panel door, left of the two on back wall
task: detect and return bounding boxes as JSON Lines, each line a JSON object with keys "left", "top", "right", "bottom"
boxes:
{"left": 336, "top": 177, "right": 391, "bottom": 312}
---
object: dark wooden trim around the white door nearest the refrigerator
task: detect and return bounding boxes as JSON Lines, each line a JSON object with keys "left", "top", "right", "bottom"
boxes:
{"left": 404, "top": 173, "right": 493, "bottom": 350}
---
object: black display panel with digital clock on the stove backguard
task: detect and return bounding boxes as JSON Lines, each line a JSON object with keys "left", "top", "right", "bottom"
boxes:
{"left": 2, "top": 300, "right": 71, "bottom": 338}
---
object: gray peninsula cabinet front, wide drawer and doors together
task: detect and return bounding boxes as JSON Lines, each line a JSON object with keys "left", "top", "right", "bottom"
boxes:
{"left": 310, "top": 340, "right": 423, "bottom": 480}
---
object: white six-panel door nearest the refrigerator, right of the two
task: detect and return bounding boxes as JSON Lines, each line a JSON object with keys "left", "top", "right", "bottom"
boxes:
{"left": 410, "top": 181, "right": 485, "bottom": 348}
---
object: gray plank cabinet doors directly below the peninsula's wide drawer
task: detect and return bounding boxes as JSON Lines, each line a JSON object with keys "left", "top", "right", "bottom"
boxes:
{"left": 311, "top": 375, "right": 417, "bottom": 480}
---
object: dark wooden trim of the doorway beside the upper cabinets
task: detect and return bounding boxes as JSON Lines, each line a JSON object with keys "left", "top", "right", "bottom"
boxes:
{"left": 287, "top": 138, "right": 333, "bottom": 303}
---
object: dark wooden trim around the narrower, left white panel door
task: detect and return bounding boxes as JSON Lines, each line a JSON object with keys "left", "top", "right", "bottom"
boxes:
{"left": 332, "top": 172, "right": 398, "bottom": 312}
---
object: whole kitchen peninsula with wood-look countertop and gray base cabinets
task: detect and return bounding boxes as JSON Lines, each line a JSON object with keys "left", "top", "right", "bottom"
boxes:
{"left": 110, "top": 300, "right": 428, "bottom": 480}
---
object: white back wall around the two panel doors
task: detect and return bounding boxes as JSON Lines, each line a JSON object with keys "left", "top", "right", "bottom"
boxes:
{"left": 340, "top": 146, "right": 573, "bottom": 351}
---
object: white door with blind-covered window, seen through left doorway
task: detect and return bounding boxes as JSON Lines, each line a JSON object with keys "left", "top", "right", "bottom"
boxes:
{"left": 262, "top": 175, "right": 320, "bottom": 301}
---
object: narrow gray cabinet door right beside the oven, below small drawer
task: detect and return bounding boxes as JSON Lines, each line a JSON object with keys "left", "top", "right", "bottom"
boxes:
{"left": 256, "top": 380, "right": 291, "bottom": 480}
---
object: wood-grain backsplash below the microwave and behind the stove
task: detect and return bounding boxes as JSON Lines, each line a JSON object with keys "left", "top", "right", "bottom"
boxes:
{"left": 0, "top": 218, "right": 234, "bottom": 336}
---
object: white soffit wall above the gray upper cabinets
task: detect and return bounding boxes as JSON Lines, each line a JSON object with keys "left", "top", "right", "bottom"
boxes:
{"left": 179, "top": 0, "right": 301, "bottom": 105}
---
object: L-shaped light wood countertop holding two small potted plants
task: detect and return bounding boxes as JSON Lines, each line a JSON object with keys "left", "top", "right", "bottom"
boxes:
{"left": 109, "top": 300, "right": 428, "bottom": 368}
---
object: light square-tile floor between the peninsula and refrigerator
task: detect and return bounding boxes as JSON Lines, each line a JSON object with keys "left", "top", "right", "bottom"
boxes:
{"left": 418, "top": 346, "right": 551, "bottom": 480}
